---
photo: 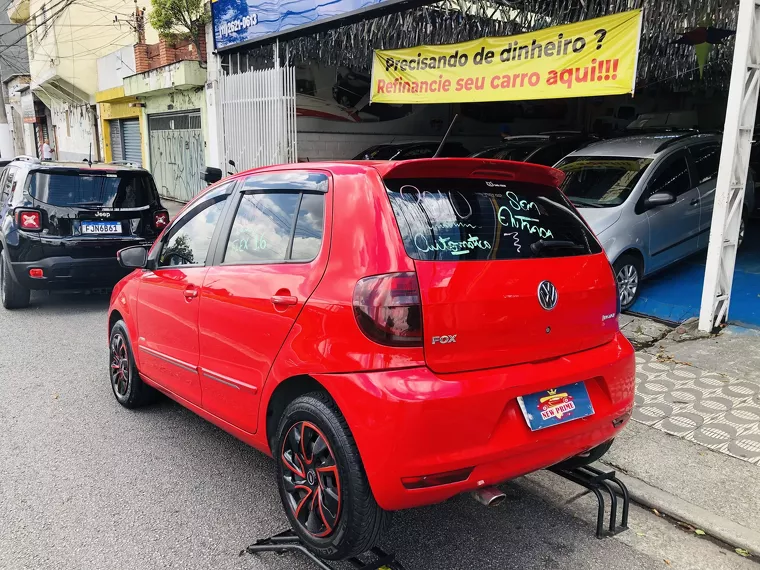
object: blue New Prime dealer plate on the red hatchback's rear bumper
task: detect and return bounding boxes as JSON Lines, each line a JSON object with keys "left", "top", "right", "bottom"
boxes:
{"left": 517, "top": 382, "right": 594, "bottom": 431}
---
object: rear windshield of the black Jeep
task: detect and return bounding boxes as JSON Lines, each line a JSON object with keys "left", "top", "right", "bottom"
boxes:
{"left": 29, "top": 171, "right": 157, "bottom": 208}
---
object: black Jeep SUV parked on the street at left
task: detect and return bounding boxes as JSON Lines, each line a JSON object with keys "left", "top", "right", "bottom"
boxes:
{"left": 0, "top": 157, "right": 169, "bottom": 309}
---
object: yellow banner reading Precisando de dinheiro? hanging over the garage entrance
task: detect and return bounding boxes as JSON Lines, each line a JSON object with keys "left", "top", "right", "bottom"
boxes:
{"left": 371, "top": 10, "right": 641, "bottom": 104}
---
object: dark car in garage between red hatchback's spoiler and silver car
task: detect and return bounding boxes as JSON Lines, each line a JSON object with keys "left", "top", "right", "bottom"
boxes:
{"left": 472, "top": 131, "right": 598, "bottom": 166}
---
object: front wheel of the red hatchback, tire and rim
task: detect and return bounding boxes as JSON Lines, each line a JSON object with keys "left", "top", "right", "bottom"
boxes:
{"left": 108, "top": 321, "right": 156, "bottom": 409}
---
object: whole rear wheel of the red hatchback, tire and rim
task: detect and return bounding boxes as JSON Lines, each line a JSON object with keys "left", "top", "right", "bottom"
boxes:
{"left": 273, "top": 392, "right": 391, "bottom": 560}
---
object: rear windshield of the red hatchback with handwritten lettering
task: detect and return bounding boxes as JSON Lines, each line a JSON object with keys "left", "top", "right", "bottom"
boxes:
{"left": 386, "top": 179, "right": 601, "bottom": 261}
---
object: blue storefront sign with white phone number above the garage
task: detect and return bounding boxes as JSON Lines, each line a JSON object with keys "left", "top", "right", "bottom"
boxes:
{"left": 211, "top": 0, "right": 403, "bottom": 50}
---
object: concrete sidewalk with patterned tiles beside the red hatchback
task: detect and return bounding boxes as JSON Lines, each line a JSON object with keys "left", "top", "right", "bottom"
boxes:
{"left": 603, "top": 315, "right": 760, "bottom": 555}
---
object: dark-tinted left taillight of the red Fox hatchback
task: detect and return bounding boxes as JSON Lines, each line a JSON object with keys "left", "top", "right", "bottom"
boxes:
{"left": 354, "top": 273, "right": 422, "bottom": 347}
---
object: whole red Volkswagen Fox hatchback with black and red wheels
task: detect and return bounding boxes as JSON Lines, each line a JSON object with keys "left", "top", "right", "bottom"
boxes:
{"left": 108, "top": 159, "right": 634, "bottom": 558}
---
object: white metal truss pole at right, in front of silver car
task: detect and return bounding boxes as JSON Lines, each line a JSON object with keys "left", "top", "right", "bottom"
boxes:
{"left": 699, "top": 0, "right": 760, "bottom": 332}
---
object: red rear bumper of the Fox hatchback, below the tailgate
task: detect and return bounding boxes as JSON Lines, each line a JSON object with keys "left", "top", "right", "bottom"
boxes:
{"left": 317, "top": 334, "right": 635, "bottom": 510}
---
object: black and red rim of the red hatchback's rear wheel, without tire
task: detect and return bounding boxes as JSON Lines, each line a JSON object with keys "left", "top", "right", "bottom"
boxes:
{"left": 280, "top": 421, "right": 341, "bottom": 538}
